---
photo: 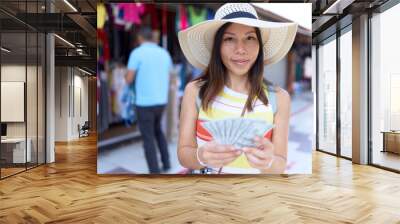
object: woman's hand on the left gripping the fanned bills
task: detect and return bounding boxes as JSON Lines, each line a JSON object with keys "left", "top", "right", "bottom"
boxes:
{"left": 197, "top": 141, "right": 242, "bottom": 168}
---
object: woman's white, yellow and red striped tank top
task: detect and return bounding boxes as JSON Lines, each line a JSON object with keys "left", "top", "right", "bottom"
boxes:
{"left": 196, "top": 86, "right": 276, "bottom": 174}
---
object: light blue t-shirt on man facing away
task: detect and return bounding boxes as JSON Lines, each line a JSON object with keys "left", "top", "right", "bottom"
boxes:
{"left": 128, "top": 42, "right": 172, "bottom": 106}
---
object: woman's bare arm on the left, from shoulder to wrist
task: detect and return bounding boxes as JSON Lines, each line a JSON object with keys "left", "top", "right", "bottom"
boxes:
{"left": 178, "top": 82, "right": 203, "bottom": 169}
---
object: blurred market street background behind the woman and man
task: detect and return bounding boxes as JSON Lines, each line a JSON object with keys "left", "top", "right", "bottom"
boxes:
{"left": 97, "top": 3, "right": 315, "bottom": 174}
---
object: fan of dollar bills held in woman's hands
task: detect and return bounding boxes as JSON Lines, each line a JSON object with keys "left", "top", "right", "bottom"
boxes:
{"left": 203, "top": 118, "right": 274, "bottom": 148}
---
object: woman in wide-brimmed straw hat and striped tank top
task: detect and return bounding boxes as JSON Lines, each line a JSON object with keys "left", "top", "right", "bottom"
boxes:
{"left": 178, "top": 3, "right": 297, "bottom": 173}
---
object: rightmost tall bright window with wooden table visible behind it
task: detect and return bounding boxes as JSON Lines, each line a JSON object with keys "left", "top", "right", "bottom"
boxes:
{"left": 370, "top": 1, "right": 400, "bottom": 171}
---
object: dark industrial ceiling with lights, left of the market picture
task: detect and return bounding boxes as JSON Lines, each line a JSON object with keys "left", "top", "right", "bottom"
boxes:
{"left": 0, "top": 0, "right": 97, "bottom": 72}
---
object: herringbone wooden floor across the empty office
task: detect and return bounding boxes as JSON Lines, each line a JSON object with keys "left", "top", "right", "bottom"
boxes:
{"left": 0, "top": 134, "right": 400, "bottom": 224}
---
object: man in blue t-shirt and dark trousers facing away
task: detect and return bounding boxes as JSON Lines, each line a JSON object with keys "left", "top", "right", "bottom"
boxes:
{"left": 126, "top": 27, "right": 172, "bottom": 173}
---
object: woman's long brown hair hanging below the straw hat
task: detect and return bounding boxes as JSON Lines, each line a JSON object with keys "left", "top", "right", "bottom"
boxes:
{"left": 195, "top": 22, "right": 271, "bottom": 116}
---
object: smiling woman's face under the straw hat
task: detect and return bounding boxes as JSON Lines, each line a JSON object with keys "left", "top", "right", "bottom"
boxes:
{"left": 221, "top": 23, "right": 260, "bottom": 76}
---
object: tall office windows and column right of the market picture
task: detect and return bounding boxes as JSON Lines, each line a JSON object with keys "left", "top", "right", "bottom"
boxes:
{"left": 313, "top": 1, "right": 400, "bottom": 171}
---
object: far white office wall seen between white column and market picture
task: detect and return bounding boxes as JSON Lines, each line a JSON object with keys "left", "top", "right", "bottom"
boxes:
{"left": 55, "top": 67, "right": 88, "bottom": 141}
